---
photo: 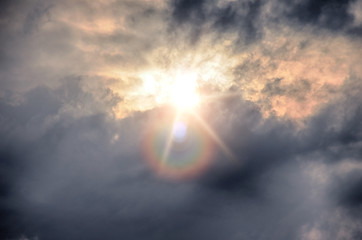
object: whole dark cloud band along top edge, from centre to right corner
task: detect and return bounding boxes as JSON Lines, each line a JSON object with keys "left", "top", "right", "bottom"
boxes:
{"left": 171, "top": 0, "right": 362, "bottom": 44}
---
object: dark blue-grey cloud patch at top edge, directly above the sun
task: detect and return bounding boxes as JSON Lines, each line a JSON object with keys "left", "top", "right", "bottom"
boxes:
{"left": 171, "top": 0, "right": 262, "bottom": 44}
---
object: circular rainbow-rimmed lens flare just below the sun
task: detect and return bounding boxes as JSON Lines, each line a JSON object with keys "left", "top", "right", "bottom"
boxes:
{"left": 144, "top": 119, "right": 213, "bottom": 179}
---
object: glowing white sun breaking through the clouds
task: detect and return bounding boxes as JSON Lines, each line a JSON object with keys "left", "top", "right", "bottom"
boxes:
{"left": 170, "top": 73, "right": 200, "bottom": 110}
